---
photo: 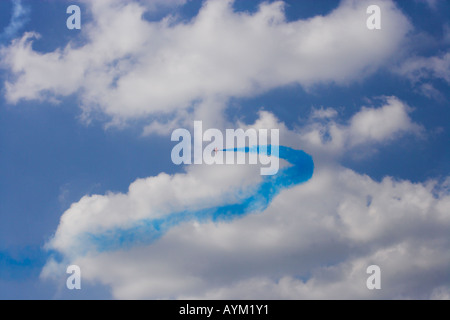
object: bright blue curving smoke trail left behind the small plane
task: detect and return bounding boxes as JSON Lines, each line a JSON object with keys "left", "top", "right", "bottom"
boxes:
{"left": 87, "top": 146, "right": 314, "bottom": 252}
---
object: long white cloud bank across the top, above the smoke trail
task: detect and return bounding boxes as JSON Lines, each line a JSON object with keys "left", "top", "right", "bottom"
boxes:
{"left": 2, "top": 0, "right": 411, "bottom": 127}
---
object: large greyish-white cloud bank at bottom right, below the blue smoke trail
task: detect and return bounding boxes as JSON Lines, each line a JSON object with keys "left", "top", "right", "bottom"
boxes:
{"left": 43, "top": 162, "right": 450, "bottom": 299}
